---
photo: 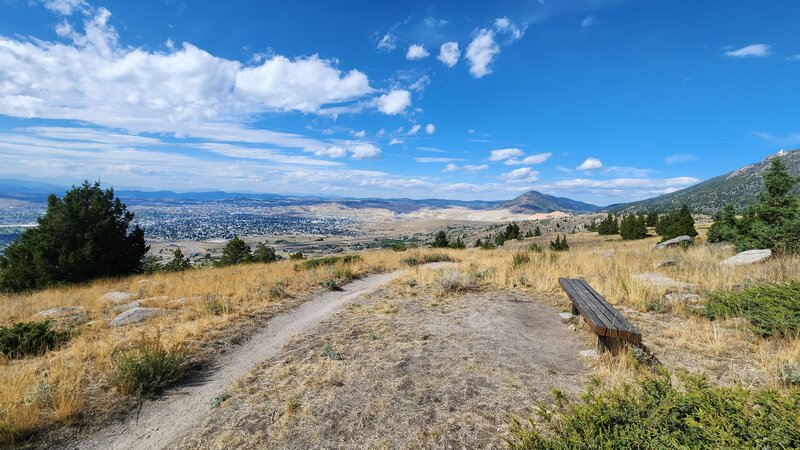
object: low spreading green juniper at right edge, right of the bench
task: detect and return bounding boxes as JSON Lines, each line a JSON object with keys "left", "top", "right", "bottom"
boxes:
{"left": 700, "top": 281, "right": 800, "bottom": 337}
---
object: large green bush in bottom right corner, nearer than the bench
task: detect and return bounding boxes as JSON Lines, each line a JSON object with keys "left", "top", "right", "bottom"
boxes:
{"left": 509, "top": 374, "right": 800, "bottom": 449}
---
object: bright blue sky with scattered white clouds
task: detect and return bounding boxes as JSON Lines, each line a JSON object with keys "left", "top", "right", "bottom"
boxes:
{"left": 0, "top": 0, "right": 800, "bottom": 205}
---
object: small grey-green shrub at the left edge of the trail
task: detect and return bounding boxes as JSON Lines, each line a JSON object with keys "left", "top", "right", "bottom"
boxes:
{"left": 111, "top": 335, "right": 187, "bottom": 397}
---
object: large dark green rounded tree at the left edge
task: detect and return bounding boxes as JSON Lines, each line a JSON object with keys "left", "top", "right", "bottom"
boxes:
{"left": 0, "top": 181, "right": 148, "bottom": 292}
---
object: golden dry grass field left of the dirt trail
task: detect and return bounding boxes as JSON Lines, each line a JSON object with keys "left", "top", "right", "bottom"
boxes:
{"left": 0, "top": 251, "right": 466, "bottom": 442}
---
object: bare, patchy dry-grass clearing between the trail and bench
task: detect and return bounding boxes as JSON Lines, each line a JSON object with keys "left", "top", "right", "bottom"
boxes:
{"left": 176, "top": 278, "right": 588, "bottom": 449}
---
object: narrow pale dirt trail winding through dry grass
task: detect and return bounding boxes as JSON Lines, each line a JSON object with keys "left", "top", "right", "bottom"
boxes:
{"left": 70, "top": 264, "right": 435, "bottom": 450}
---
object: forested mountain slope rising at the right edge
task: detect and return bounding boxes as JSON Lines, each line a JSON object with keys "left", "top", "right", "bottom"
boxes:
{"left": 605, "top": 149, "right": 800, "bottom": 213}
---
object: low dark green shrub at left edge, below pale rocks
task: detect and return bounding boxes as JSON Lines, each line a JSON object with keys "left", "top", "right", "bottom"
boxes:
{"left": 0, "top": 321, "right": 69, "bottom": 359}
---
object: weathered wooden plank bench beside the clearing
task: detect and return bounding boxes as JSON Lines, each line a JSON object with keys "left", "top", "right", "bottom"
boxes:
{"left": 558, "top": 278, "right": 642, "bottom": 352}
